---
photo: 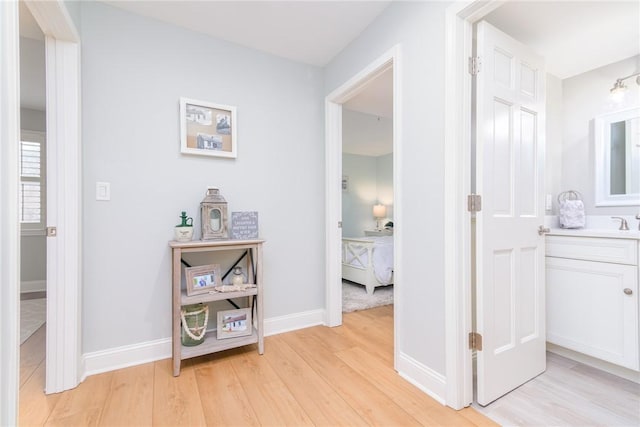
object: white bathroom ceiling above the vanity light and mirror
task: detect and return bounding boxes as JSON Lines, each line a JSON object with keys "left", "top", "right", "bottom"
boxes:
{"left": 485, "top": 0, "right": 640, "bottom": 79}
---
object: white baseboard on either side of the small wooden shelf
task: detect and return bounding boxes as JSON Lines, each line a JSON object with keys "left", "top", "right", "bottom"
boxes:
{"left": 82, "top": 310, "right": 324, "bottom": 381}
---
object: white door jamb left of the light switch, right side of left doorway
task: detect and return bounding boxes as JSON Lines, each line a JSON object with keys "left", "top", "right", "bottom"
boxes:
{"left": 25, "top": 0, "right": 83, "bottom": 393}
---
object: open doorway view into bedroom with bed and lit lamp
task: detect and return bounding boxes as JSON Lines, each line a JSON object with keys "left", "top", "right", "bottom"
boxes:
{"left": 341, "top": 67, "right": 393, "bottom": 313}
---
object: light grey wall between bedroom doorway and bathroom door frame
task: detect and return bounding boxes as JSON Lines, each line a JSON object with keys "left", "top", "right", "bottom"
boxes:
{"left": 325, "top": 2, "right": 449, "bottom": 379}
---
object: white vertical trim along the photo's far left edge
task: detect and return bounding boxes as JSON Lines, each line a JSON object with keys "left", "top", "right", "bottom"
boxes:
{"left": 0, "top": 1, "right": 20, "bottom": 426}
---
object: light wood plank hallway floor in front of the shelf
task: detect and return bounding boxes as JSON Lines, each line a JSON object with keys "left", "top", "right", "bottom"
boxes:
{"left": 19, "top": 306, "right": 496, "bottom": 426}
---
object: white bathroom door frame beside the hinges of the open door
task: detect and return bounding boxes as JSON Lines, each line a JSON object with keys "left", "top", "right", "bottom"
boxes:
{"left": 444, "top": 0, "right": 505, "bottom": 409}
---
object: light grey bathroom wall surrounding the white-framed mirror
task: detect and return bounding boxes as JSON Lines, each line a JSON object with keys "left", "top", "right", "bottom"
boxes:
{"left": 562, "top": 56, "right": 640, "bottom": 215}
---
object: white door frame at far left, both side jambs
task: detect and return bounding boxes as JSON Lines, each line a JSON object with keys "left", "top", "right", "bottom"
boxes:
{"left": 0, "top": 0, "right": 83, "bottom": 408}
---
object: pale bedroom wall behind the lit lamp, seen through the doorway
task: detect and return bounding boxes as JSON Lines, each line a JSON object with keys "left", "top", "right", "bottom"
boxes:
{"left": 342, "top": 153, "right": 393, "bottom": 237}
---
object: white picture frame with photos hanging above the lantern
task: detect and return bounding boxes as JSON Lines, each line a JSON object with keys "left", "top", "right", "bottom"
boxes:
{"left": 180, "top": 97, "right": 238, "bottom": 159}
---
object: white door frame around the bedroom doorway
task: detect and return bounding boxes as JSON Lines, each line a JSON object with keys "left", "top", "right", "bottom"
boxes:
{"left": 324, "top": 45, "right": 404, "bottom": 363}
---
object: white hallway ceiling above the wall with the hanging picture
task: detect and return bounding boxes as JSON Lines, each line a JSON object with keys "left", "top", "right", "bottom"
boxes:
{"left": 105, "top": 0, "right": 391, "bottom": 67}
